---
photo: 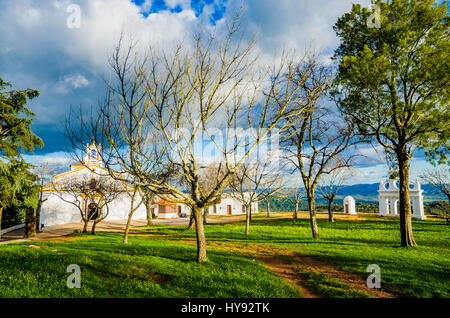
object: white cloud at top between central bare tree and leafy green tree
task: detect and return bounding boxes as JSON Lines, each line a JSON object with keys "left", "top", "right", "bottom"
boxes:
{"left": 223, "top": 0, "right": 370, "bottom": 54}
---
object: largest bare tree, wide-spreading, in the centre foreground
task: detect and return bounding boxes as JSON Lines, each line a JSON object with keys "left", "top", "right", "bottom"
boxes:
{"left": 66, "top": 18, "right": 324, "bottom": 262}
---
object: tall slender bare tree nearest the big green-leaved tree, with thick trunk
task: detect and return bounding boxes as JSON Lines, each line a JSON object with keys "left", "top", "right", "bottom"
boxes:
{"left": 283, "top": 60, "right": 359, "bottom": 238}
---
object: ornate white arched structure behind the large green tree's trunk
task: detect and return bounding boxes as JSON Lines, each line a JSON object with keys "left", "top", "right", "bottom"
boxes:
{"left": 378, "top": 180, "right": 427, "bottom": 220}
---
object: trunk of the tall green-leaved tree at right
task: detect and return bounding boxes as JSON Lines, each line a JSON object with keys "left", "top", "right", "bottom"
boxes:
{"left": 397, "top": 155, "right": 417, "bottom": 247}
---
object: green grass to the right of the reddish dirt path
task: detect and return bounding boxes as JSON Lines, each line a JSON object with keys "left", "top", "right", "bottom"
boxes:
{"left": 141, "top": 216, "right": 450, "bottom": 297}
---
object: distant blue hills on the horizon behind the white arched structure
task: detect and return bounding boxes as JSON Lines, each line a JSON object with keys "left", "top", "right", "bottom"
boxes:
{"left": 286, "top": 183, "right": 447, "bottom": 203}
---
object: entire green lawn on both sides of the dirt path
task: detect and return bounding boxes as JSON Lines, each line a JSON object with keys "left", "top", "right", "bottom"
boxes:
{"left": 0, "top": 216, "right": 450, "bottom": 298}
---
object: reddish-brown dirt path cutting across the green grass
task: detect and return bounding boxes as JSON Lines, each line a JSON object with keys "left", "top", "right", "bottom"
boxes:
{"left": 132, "top": 234, "right": 399, "bottom": 298}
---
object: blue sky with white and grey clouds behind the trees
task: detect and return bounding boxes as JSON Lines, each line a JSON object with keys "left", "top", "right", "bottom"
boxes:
{"left": 0, "top": 0, "right": 438, "bottom": 184}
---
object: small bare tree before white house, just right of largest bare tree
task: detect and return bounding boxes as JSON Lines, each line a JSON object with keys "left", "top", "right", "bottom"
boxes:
{"left": 230, "top": 155, "right": 284, "bottom": 235}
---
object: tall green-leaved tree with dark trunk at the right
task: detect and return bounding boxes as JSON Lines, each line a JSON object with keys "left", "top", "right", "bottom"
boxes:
{"left": 334, "top": 0, "right": 450, "bottom": 246}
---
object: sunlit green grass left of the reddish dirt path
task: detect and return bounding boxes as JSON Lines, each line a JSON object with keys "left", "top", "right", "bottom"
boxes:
{"left": 0, "top": 233, "right": 300, "bottom": 298}
